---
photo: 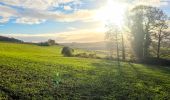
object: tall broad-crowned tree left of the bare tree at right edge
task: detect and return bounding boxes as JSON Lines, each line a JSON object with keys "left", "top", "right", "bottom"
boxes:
{"left": 128, "top": 5, "right": 165, "bottom": 58}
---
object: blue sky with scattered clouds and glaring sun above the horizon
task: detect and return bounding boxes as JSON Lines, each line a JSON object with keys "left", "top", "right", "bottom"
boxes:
{"left": 0, "top": 0, "right": 170, "bottom": 43}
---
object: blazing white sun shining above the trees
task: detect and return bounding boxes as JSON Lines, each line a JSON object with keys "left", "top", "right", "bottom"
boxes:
{"left": 95, "top": 0, "right": 125, "bottom": 26}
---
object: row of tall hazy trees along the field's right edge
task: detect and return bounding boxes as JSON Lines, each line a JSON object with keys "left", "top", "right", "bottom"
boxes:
{"left": 106, "top": 5, "right": 170, "bottom": 60}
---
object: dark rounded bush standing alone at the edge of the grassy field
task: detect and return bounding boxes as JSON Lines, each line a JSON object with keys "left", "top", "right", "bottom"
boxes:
{"left": 61, "top": 47, "right": 74, "bottom": 57}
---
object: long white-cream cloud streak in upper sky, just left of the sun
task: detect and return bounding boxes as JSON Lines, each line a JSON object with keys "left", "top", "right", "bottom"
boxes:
{"left": 18, "top": 10, "right": 95, "bottom": 22}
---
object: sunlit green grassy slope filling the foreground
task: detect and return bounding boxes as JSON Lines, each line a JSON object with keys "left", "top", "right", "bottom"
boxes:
{"left": 0, "top": 43, "right": 170, "bottom": 100}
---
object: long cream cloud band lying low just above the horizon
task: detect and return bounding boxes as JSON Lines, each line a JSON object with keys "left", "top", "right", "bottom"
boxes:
{"left": 3, "top": 29, "right": 104, "bottom": 43}
